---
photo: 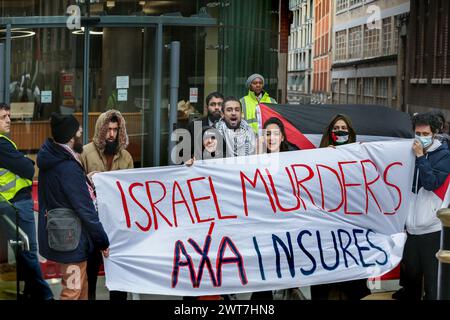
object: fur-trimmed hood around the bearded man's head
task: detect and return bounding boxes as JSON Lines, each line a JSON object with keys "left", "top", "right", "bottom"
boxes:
{"left": 93, "top": 109, "right": 128, "bottom": 152}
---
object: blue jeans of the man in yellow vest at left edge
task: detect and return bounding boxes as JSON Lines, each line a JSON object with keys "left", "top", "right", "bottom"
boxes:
{"left": 10, "top": 199, "right": 53, "bottom": 300}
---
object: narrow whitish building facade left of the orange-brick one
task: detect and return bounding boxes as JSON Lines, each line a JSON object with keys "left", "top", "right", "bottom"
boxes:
{"left": 287, "top": 0, "right": 314, "bottom": 103}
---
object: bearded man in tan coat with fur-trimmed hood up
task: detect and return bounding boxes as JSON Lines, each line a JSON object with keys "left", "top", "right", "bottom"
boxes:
{"left": 80, "top": 110, "right": 133, "bottom": 300}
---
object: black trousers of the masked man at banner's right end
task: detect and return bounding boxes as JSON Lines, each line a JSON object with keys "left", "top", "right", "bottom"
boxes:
{"left": 400, "top": 231, "right": 441, "bottom": 300}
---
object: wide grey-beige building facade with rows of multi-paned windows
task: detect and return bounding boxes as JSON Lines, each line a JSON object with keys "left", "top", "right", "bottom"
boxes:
{"left": 331, "top": 0, "right": 410, "bottom": 110}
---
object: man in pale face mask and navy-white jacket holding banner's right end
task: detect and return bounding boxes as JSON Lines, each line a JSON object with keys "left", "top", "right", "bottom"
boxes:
{"left": 397, "top": 113, "right": 450, "bottom": 300}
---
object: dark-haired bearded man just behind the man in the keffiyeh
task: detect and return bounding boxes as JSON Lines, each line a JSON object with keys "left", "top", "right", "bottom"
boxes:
{"left": 189, "top": 91, "right": 223, "bottom": 156}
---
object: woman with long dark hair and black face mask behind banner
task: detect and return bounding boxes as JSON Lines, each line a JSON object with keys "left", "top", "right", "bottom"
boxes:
{"left": 311, "top": 114, "right": 370, "bottom": 300}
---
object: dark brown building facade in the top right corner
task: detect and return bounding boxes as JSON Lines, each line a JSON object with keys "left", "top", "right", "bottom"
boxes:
{"left": 405, "top": 0, "right": 450, "bottom": 119}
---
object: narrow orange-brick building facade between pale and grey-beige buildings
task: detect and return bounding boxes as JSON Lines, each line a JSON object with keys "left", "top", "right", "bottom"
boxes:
{"left": 311, "top": 0, "right": 334, "bottom": 104}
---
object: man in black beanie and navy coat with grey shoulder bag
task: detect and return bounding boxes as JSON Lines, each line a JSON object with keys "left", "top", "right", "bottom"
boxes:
{"left": 37, "top": 113, "right": 109, "bottom": 300}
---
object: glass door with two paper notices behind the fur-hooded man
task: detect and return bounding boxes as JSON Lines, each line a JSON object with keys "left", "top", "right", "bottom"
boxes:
{"left": 86, "top": 26, "right": 155, "bottom": 167}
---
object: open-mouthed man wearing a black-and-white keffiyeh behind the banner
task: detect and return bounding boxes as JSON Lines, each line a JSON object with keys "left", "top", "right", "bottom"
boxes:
{"left": 215, "top": 97, "right": 256, "bottom": 157}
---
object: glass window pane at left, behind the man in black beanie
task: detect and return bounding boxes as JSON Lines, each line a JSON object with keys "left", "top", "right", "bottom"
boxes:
{"left": 9, "top": 28, "right": 83, "bottom": 166}
